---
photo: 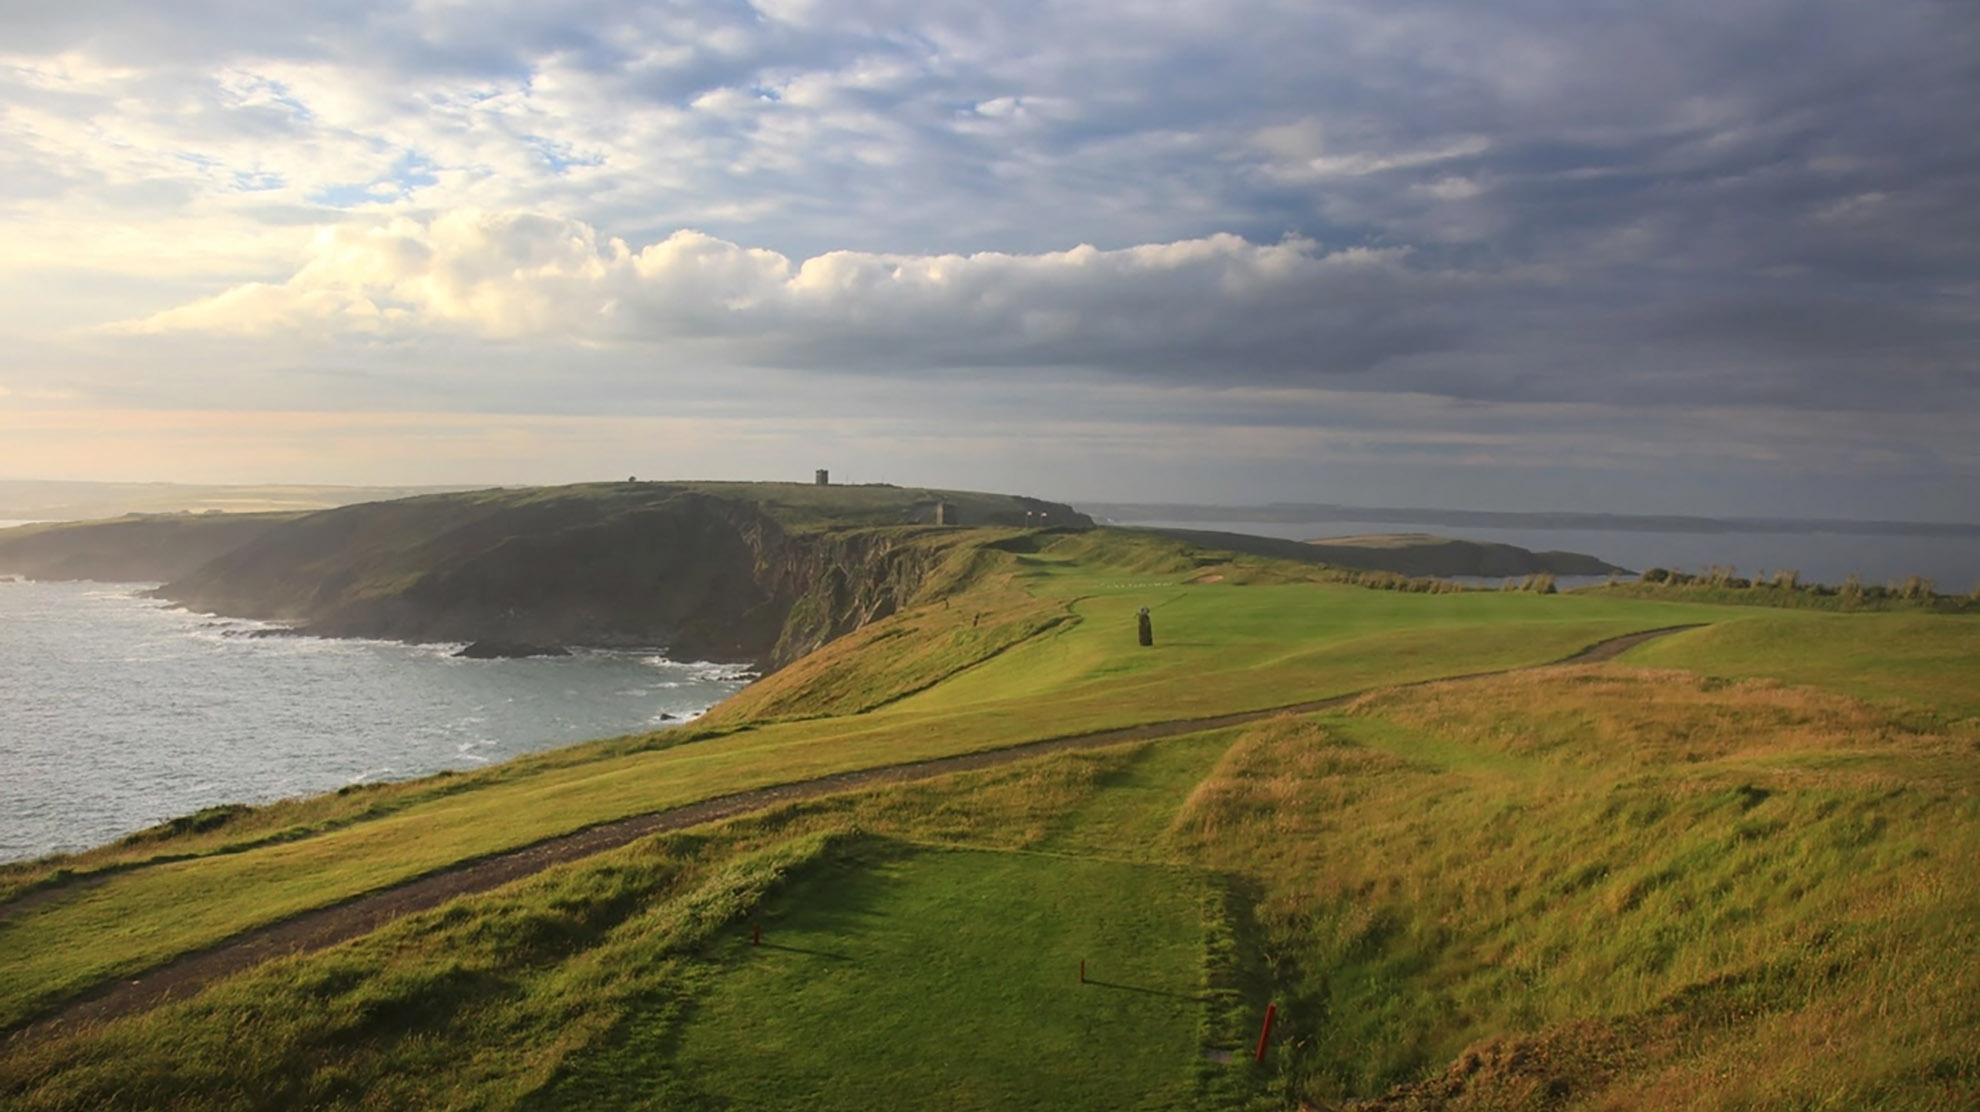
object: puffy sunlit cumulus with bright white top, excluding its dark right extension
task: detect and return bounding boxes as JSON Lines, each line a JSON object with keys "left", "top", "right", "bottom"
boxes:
{"left": 117, "top": 210, "right": 1434, "bottom": 366}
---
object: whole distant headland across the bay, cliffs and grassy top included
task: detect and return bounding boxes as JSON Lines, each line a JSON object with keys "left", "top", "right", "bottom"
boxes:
{"left": 0, "top": 483, "right": 1091, "bottom": 667}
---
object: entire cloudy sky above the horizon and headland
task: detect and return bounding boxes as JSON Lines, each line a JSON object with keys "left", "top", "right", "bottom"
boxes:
{"left": 0, "top": 0, "right": 1980, "bottom": 520}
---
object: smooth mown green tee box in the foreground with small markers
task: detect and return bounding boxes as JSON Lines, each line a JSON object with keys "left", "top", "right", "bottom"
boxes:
{"left": 655, "top": 851, "right": 1204, "bottom": 1112}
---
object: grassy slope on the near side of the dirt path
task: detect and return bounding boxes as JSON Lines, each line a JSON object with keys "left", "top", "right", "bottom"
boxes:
{"left": 0, "top": 645, "right": 1980, "bottom": 1110}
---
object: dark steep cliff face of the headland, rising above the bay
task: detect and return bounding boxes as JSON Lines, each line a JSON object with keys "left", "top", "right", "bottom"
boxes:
{"left": 158, "top": 491, "right": 950, "bottom": 667}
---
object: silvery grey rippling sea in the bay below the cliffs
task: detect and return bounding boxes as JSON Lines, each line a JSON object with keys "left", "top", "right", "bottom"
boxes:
{"left": 0, "top": 580, "right": 748, "bottom": 861}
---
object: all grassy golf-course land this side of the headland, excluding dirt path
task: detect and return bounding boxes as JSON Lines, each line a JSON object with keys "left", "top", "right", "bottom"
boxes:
{"left": 0, "top": 492, "right": 1980, "bottom": 1110}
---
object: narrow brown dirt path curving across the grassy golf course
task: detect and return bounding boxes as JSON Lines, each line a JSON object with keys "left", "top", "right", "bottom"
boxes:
{"left": 8, "top": 625, "right": 1697, "bottom": 1041}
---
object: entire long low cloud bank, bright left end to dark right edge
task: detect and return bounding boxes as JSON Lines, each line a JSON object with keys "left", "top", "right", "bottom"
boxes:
{"left": 107, "top": 192, "right": 1980, "bottom": 421}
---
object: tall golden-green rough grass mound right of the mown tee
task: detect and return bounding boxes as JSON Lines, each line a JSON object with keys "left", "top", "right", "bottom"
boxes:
{"left": 1176, "top": 667, "right": 1980, "bottom": 1110}
